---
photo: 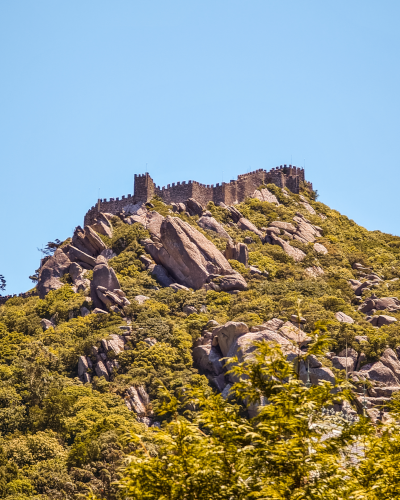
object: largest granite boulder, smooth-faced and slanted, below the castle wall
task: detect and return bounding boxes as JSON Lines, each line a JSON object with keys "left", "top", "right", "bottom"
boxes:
{"left": 142, "top": 216, "right": 246, "bottom": 290}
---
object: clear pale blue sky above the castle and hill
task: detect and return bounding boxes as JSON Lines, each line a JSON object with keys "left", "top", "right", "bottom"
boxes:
{"left": 0, "top": 0, "right": 400, "bottom": 293}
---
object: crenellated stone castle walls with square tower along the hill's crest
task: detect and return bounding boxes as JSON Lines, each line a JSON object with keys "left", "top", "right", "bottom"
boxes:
{"left": 84, "top": 165, "right": 312, "bottom": 225}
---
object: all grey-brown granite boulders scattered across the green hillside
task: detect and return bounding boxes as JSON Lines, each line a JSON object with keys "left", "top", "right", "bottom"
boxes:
{"left": 30, "top": 188, "right": 400, "bottom": 425}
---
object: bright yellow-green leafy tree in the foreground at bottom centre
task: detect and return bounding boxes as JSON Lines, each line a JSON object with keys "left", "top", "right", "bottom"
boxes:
{"left": 114, "top": 344, "right": 344, "bottom": 500}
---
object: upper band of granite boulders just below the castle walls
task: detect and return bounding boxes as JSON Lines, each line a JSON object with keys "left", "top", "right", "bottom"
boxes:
{"left": 37, "top": 188, "right": 327, "bottom": 304}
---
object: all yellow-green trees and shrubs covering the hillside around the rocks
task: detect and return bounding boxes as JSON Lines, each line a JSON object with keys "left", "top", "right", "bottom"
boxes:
{"left": 0, "top": 185, "right": 400, "bottom": 500}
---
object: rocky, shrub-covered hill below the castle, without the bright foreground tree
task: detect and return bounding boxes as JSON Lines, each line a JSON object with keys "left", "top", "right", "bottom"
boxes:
{"left": 0, "top": 184, "right": 400, "bottom": 499}
